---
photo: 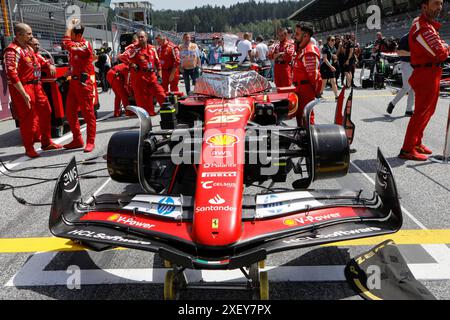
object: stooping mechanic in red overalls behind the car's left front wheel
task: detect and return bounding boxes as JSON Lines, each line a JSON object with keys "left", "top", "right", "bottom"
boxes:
{"left": 106, "top": 63, "right": 130, "bottom": 117}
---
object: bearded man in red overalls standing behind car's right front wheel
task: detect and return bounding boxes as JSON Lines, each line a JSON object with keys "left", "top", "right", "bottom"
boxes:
{"left": 293, "top": 22, "right": 322, "bottom": 127}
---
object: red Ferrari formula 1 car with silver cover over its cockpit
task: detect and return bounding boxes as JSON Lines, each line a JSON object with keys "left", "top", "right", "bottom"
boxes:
{"left": 50, "top": 71, "right": 402, "bottom": 299}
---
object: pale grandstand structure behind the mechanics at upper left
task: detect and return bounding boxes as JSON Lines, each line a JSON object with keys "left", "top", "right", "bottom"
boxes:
{"left": 0, "top": 0, "right": 159, "bottom": 53}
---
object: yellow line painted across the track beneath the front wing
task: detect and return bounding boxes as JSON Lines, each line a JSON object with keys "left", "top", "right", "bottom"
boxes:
{"left": 0, "top": 229, "right": 450, "bottom": 253}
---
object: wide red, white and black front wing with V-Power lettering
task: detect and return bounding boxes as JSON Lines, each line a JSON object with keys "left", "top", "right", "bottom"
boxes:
{"left": 49, "top": 150, "right": 402, "bottom": 269}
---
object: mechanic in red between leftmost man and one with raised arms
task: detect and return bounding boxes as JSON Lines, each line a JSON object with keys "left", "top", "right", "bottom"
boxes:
{"left": 29, "top": 38, "right": 62, "bottom": 150}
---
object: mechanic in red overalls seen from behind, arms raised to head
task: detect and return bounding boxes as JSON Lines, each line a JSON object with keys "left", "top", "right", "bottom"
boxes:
{"left": 63, "top": 19, "right": 97, "bottom": 152}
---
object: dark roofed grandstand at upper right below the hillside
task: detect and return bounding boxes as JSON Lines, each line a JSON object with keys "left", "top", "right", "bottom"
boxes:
{"left": 289, "top": 0, "right": 450, "bottom": 45}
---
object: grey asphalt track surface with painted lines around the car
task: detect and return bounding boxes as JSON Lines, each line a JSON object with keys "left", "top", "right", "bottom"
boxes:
{"left": 0, "top": 72, "right": 450, "bottom": 300}
